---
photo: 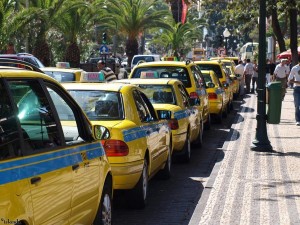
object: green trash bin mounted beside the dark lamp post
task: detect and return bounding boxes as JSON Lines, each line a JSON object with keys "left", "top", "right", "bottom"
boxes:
{"left": 267, "top": 81, "right": 282, "bottom": 124}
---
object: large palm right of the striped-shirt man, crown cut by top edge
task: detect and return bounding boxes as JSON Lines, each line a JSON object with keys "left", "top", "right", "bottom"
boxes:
{"left": 106, "top": 0, "right": 170, "bottom": 66}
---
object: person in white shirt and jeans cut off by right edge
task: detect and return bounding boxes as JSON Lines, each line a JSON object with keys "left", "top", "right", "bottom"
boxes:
{"left": 288, "top": 57, "right": 300, "bottom": 126}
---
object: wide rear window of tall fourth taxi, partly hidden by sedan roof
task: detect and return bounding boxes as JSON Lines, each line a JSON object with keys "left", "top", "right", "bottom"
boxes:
{"left": 132, "top": 66, "right": 192, "bottom": 88}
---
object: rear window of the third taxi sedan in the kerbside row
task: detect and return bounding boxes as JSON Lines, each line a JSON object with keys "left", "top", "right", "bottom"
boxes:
{"left": 139, "top": 84, "right": 176, "bottom": 104}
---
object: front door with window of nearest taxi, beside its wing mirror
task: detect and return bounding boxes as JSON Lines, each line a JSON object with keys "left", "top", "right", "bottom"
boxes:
{"left": 47, "top": 85, "right": 104, "bottom": 224}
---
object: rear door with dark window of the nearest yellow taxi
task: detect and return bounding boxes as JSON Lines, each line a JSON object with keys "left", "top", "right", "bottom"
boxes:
{"left": 8, "top": 79, "right": 73, "bottom": 224}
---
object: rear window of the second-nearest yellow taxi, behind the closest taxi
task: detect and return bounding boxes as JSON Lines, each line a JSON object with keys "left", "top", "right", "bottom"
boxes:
{"left": 69, "top": 90, "right": 124, "bottom": 121}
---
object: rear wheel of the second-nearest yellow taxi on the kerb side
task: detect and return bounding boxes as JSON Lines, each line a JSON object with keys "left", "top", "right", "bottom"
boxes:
{"left": 131, "top": 159, "right": 149, "bottom": 209}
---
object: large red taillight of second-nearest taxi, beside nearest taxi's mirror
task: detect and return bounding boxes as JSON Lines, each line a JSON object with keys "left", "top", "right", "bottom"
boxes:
{"left": 101, "top": 140, "right": 129, "bottom": 156}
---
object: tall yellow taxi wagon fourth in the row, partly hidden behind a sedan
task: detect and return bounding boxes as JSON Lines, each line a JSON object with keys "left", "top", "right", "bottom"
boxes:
{"left": 129, "top": 60, "right": 211, "bottom": 129}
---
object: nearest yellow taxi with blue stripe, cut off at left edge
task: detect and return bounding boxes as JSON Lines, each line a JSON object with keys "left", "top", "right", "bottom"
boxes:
{"left": 0, "top": 59, "right": 113, "bottom": 225}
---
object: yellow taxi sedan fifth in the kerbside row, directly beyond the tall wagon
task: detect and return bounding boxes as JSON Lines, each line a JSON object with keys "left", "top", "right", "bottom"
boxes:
{"left": 202, "top": 70, "right": 227, "bottom": 123}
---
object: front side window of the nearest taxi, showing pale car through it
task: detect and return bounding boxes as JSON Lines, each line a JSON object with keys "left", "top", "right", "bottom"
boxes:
{"left": 47, "top": 86, "right": 84, "bottom": 145}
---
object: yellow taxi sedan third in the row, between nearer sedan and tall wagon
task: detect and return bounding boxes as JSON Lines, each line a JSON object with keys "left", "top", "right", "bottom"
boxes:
{"left": 114, "top": 78, "right": 203, "bottom": 162}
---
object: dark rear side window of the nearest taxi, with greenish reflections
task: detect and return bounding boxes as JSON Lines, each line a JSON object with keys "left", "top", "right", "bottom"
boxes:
{"left": 8, "top": 80, "right": 61, "bottom": 154}
